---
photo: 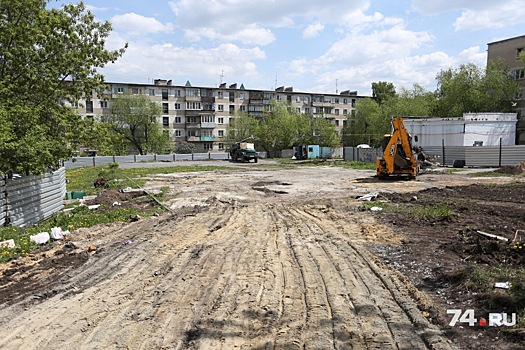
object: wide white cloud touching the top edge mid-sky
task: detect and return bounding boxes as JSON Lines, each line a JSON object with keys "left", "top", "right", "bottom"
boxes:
{"left": 169, "top": 0, "right": 370, "bottom": 45}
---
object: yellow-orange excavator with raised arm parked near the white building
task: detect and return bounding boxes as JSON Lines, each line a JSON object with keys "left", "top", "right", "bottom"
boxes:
{"left": 376, "top": 117, "right": 419, "bottom": 179}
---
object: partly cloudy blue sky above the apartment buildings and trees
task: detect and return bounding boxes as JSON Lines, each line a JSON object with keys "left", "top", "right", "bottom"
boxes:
{"left": 51, "top": 0, "right": 525, "bottom": 96}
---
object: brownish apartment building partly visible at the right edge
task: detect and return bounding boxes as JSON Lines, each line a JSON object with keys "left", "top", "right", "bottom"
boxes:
{"left": 487, "top": 35, "right": 525, "bottom": 144}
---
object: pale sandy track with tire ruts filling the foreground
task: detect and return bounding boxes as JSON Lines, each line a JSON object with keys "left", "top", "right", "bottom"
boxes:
{"left": 0, "top": 203, "right": 446, "bottom": 349}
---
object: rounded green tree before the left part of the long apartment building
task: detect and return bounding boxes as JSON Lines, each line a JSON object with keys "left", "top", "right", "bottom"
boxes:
{"left": 103, "top": 93, "right": 169, "bottom": 154}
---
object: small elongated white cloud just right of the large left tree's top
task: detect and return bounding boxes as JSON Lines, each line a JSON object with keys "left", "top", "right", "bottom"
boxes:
{"left": 111, "top": 13, "right": 173, "bottom": 35}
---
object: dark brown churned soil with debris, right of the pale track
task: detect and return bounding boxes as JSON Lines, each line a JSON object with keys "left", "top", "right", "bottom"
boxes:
{"left": 369, "top": 182, "right": 525, "bottom": 349}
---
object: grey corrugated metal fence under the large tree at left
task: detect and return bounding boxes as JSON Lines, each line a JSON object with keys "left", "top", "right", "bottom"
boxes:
{"left": 0, "top": 167, "right": 66, "bottom": 227}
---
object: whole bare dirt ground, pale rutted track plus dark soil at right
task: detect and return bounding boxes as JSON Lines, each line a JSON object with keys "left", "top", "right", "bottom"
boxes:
{"left": 0, "top": 162, "right": 525, "bottom": 349}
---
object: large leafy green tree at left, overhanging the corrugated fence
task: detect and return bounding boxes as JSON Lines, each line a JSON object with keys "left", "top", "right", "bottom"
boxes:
{"left": 0, "top": 0, "right": 125, "bottom": 174}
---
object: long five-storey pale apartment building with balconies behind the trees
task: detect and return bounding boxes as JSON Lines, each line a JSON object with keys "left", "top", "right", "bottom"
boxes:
{"left": 74, "top": 79, "right": 366, "bottom": 152}
